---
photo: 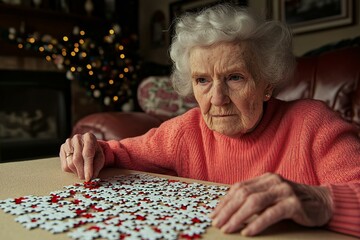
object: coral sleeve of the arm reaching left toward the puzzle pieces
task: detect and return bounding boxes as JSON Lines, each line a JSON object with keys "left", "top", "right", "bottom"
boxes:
{"left": 98, "top": 111, "right": 191, "bottom": 175}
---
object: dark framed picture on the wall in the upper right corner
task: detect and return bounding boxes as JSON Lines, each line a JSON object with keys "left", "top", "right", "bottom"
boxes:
{"left": 268, "top": 0, "right": 354, "bottom": 34}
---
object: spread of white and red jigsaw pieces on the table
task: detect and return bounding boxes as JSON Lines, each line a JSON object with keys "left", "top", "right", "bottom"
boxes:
{"left": 0, "top": 174, "right": 228, "bottom": 240}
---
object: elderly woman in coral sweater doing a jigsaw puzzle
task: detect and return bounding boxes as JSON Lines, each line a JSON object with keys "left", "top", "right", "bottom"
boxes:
{"left": 60, "top": 5, "right": 360, "bottom": 236}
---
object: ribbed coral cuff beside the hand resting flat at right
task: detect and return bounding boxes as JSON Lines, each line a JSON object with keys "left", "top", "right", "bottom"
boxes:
{"left": 327, "top": 183, "right": 360, "bottom": 237}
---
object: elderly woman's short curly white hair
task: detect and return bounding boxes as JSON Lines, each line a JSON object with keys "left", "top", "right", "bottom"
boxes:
{"left": 170, "top": 4, "right": 295, "bottom": 96}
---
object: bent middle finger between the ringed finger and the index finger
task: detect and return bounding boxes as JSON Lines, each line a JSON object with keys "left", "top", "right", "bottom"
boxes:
{"left": 72, "top": 134, "right": 84, "bottom": 179}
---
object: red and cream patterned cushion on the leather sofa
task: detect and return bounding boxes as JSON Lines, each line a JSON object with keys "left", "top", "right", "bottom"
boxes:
{"left": 137, "top": 76, "right": 197, "bottom": 119}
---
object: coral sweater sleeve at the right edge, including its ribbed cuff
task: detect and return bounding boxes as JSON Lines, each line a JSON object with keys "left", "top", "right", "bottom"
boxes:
{"left": 305, "top": 100, "right": 360, "bottom": 237}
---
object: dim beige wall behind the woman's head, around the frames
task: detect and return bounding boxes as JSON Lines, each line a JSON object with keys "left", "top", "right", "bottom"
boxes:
{"left": 139, "top": 0, "right": 360, "bottom": 64}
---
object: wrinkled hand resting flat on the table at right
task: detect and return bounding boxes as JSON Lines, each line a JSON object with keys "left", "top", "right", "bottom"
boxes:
{"left": 210, "top": 173, "right": 332, "bottom": 236}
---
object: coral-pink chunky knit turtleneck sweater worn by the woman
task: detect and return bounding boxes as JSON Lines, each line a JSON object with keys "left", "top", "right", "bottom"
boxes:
{"left": 100, "top": 99, "right": 360, "bottom": 237}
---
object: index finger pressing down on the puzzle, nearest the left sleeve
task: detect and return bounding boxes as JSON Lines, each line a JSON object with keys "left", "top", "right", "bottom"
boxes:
{"left": 82, "top": 133, "right": 97, "bottom": 181}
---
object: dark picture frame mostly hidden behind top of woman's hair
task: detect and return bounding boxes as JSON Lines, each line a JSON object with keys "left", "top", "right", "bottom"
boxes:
{"left": 169, "top": 0, "right": 248, "bottom": 36}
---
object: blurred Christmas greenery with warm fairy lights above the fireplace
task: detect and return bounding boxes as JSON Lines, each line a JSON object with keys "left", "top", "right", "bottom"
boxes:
{"left": 4, "top": 22, "right": 140, "bottom": 111}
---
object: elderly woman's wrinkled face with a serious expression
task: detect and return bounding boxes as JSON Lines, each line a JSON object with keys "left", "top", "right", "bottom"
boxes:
{"left": 190, "top": 43, "right": 272, "bottom": 137}
